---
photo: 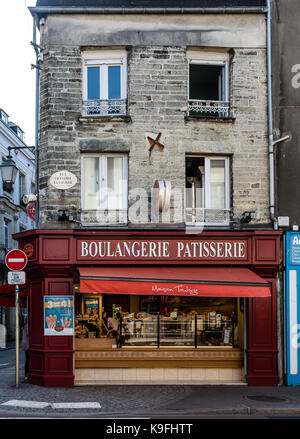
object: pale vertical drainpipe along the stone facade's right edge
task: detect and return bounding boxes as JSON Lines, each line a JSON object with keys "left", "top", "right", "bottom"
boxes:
{"left": 267, "top": 0, "right": 278, "bottom": 230}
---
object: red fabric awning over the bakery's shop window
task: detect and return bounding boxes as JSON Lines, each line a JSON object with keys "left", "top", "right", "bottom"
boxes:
{"left": 79, "top": 265, "right": 271, "bottom": 297}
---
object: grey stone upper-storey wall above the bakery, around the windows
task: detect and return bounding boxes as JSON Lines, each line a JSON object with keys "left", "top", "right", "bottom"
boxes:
{"left": 35, "top": 9, "right": 270, "bottom": 228}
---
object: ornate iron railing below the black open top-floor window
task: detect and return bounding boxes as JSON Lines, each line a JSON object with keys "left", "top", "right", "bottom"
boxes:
{"left": 188, "top": 99, "right": 229, "bottom": 118}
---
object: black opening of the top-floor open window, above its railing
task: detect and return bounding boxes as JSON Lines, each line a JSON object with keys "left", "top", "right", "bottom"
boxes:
{"left": 189, "top": 64, "right": 223, "bottom": 101}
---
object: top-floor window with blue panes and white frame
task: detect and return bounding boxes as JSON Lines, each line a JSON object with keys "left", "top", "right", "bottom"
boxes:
{"left": 83, "top": 50, "right": 127, "bottom": 116}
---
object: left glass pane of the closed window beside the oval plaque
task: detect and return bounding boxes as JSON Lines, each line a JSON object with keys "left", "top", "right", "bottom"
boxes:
{"left": 83, "top": 157, "right": 100, "bottom": 210}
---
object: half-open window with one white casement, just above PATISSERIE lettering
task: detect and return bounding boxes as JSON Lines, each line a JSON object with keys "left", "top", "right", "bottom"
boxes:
{"left": 185, "top": 156, "right": 230, "bottom": 226}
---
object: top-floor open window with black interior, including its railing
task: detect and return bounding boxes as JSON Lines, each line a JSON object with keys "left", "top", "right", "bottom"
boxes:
{"left": 188, "top": 51, "right": 229, "bottom": 117}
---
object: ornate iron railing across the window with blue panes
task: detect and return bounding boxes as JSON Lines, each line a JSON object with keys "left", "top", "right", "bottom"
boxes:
{"left": 83, "top": 99, "right": 127, "bottom": 117}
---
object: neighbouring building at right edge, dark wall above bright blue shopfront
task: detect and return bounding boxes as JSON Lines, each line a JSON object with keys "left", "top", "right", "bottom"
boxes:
{"left": 272, "top": 0, "right": 300, "bottom": 385}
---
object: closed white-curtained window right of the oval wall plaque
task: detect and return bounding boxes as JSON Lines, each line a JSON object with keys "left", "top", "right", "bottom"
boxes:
{"left": 82, "top": 154, "right": 128, "bottom": 224}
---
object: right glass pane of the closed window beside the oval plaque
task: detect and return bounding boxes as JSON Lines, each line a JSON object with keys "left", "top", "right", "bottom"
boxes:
{"left": 107, "top": 157, "right": 123, "bottom": 209}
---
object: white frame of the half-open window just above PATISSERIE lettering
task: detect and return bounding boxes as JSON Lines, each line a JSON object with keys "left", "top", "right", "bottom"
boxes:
{"left": 185, "top": 155, "right": 231, "bottom": 226}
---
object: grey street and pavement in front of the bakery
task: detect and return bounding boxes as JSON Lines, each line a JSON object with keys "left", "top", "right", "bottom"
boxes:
{"left": 0, "top": 346, "right": 300, "bottom": 419}
